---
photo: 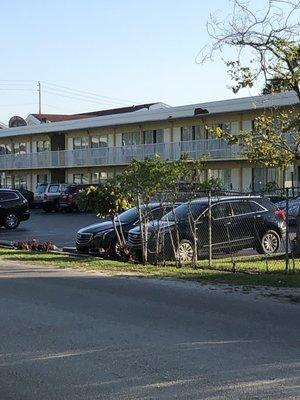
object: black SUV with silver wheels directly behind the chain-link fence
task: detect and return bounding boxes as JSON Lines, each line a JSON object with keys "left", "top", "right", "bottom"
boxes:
{"left": 128, "top": 196, "right": 286, "bottom": 261}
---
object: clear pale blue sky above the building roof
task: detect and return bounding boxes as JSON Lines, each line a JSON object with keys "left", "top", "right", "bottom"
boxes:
{"left": 0, "top": 0, "right": 268, "bottom": 123}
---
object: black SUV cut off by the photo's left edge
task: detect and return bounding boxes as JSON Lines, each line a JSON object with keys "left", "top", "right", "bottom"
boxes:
{"left": 0, "top": 189, "right": 30, "bottom": 229}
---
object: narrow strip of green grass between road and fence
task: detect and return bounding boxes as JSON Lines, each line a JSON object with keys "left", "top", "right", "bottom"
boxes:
{"left": 0, "top": 248, "right": 300, "bottom": 287}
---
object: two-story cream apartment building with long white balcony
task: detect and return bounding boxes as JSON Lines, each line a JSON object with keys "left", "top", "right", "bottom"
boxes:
{"left": 0, "top": 93, "right": 298, "bottom": 191}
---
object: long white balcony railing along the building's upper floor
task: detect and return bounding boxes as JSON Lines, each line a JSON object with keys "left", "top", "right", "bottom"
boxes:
{"left": 0, "top": 139, "right": 244, "bottom": 171}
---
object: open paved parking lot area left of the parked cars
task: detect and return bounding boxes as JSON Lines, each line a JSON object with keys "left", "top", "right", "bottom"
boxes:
{"left": 0, "top": 209, "right": 99, "bottom": 248}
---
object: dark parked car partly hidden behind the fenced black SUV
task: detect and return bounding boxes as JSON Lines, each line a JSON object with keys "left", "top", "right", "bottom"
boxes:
{"left": 76, "top": 203, "right": 177, "bottom": 257}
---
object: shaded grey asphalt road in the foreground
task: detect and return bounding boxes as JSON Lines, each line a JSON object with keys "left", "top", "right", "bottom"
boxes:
{"left": 0, "top": 262, "right": 300, "bottom": 400}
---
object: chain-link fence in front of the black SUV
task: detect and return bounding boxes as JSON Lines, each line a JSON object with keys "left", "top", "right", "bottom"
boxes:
{"left": 127, "top": 189, "right": 300, "bottom": 273}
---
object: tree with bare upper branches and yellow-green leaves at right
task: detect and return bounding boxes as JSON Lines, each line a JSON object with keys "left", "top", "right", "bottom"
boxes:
{"left": 200, "top": 0, "right": 300, "bottom": 168}
